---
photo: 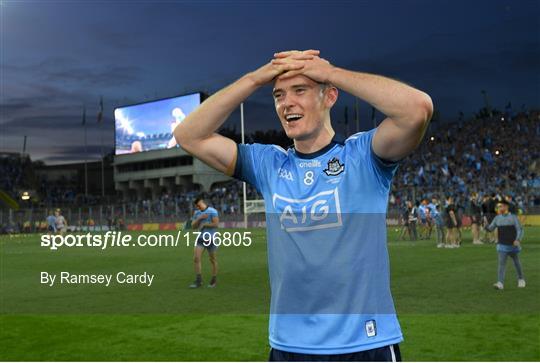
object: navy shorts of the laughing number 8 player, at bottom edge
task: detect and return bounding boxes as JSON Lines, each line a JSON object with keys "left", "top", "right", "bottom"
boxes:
{"left": 268, "top": 344, "right": 401, "bottom": 362}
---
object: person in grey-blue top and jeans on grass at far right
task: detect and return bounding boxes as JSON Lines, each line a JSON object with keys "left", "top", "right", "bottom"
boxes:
{"left": 486, "top": 199, "right": 525, "bottom": 290}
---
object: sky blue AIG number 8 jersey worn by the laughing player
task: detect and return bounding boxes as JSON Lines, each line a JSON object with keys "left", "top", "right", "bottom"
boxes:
{"left": 235, "top": 130, "right": 402, "bottom": 354}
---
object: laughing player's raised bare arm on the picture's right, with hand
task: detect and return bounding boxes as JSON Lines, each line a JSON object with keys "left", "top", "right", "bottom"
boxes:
{"left": 273, "top": 51, "right": 433, "bottom": 161}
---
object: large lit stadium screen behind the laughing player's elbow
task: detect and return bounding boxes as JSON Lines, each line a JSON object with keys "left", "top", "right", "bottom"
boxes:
{"left": 114, "top": 93, "right": 202, "bottom": 155}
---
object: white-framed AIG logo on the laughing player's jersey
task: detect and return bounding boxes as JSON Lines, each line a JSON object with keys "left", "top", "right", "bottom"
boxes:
{"left": 272, "top": 188, "right": 342, "bottom": 232}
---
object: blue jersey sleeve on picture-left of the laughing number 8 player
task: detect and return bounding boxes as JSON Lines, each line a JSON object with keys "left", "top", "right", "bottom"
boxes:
{"left": 233, "top": 144, "right": 268, "bottom": 193}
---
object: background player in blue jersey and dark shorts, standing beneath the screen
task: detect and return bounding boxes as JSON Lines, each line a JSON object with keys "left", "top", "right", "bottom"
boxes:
{"left": 189, "top": 197, "right": 219, "bottom": 289}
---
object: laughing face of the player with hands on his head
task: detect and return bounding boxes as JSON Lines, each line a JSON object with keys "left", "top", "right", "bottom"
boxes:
{"left": 272, "top": 75, "right": 334, "bottom": 140}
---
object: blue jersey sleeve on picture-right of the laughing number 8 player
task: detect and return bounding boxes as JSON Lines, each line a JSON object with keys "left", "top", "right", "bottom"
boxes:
{"left": 347, "top": 129, "right": 399, "bottom": 189}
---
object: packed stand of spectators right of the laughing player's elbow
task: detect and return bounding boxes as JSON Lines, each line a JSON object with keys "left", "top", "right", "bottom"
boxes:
{"left": 390, "top": 106, "right": 540, "bottom": 209}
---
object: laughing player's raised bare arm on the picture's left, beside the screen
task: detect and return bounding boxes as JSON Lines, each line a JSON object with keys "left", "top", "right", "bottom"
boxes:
{"left": 174, "top": 51, "right": 318, "bottom": 175}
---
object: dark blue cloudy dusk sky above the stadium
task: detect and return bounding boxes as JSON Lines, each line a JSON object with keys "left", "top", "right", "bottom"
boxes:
{"left": 0, "top": 0, "right": 540, "bottom": 164}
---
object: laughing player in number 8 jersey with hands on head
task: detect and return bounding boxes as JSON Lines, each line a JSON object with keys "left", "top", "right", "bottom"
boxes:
{"left": 174, "top": 50, "right": 433, "bottom": 361}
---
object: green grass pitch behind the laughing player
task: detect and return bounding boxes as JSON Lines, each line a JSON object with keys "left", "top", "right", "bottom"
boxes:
{"left": 0, "top": 227, "right": 540, "bottom": 361}
